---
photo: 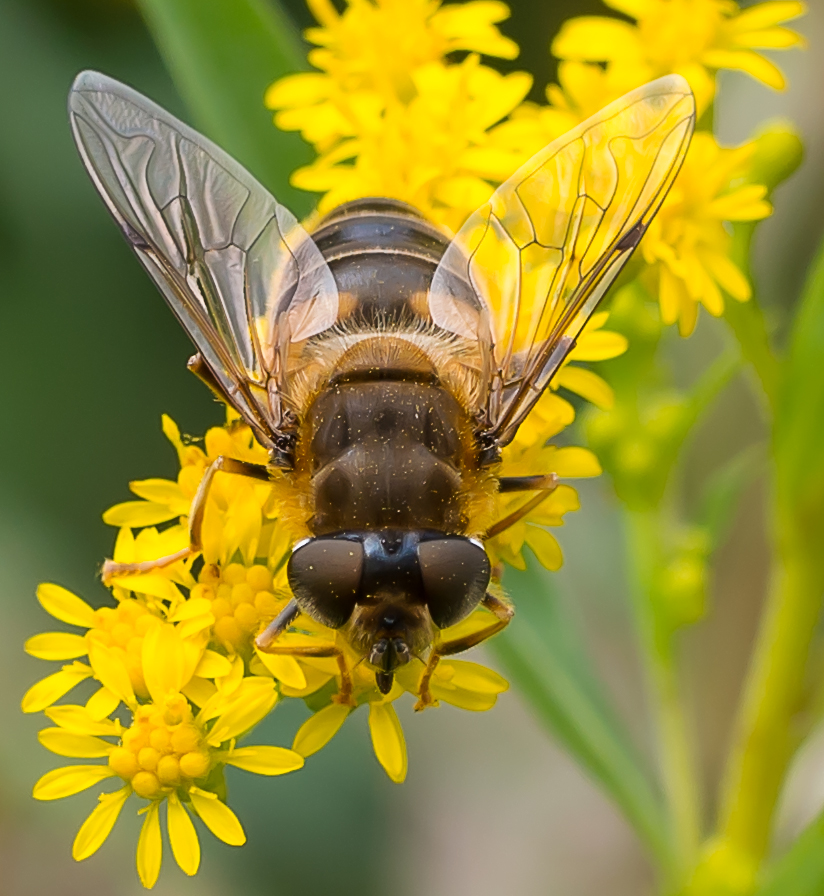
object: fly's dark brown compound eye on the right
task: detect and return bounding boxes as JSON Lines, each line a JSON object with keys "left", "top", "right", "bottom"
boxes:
{"left": 418, "top": 535, "right": 490, "bottom": 628}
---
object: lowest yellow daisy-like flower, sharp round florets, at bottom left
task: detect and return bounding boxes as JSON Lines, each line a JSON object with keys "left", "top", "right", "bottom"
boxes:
{"left": 34, "top": 625, "right": 303, "bottom": 887}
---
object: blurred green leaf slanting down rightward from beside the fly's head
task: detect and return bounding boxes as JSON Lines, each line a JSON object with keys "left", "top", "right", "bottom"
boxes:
{"left": 491, "top": 558, "right": 671, "bottom": 864}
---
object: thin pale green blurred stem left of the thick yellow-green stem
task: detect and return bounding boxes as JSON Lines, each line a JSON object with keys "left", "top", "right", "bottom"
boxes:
{"left": 624, "top": 508, "right": 701, "bottom": 878}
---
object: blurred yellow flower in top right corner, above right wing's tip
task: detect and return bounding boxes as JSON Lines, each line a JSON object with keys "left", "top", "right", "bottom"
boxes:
{"left": 552, "top": 0, "right": 806, "bottom": 113}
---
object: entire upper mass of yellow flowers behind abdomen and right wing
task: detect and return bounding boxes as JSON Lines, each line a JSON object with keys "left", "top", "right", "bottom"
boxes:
{"left": 267, "top": 0, "right": 805, "bottom": 335}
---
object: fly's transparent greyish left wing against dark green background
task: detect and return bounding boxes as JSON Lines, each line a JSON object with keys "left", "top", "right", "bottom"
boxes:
{"left": 69, "top": 72, "right": 338, "bottom": 447}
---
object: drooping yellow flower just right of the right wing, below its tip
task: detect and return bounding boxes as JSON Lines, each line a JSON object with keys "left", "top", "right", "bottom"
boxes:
{"left": 641, "top": 133, "right": 772, "bottom": 336}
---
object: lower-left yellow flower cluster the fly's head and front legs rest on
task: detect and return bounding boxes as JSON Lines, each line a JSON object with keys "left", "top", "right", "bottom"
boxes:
{"left": 23, "top": 417, "right": 520, "bottom": 887}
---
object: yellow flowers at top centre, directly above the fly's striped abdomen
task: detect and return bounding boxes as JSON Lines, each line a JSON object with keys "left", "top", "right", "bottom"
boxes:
{"left": 266, "top": 0, "right": 532, "bottom": 230}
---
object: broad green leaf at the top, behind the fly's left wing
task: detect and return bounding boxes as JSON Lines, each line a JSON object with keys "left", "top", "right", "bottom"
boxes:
{"left": 139, "top": 0, "right": 313, "bottom": 217}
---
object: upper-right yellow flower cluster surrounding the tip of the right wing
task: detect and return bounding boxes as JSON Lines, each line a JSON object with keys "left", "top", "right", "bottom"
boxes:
{"left": 495, "top": 0, "right": 805, "bottom": 336}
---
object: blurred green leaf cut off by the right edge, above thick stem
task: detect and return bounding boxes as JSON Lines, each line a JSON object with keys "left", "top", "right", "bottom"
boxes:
{"left": 774, "top": 229, "right": 824, "bottom": 544}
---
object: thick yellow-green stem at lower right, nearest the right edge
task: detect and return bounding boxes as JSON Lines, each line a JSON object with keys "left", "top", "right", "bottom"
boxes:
{"left": 720, "top": 527, "right": 824, "bottom": 867}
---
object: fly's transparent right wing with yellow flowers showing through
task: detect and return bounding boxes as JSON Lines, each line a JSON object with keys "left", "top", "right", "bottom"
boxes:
{"left": 429, "top": 75, "right": 695, "bottom": 445}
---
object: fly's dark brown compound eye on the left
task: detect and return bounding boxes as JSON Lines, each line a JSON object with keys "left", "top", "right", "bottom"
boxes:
{"left": 286, "top": 538, "right": 363, "bottom": 628}
